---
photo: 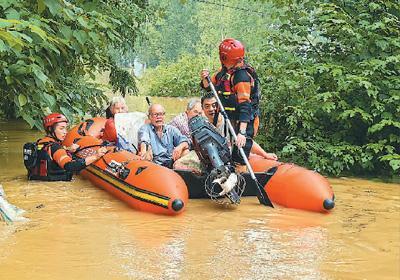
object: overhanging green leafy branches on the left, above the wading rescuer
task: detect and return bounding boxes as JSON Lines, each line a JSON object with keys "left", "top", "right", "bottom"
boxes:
{"left": 0, "top": 0, "right": 145, "bottom": 128}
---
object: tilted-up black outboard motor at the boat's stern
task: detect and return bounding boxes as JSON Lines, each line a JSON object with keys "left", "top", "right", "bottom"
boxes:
{"left": 189, "top": 116, "right": 245, "bottom": 204}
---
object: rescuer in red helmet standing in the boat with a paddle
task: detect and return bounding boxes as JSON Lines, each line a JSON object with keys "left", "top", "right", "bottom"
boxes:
{"left": 200, "top": 38, "right": 276, "bottom": 172}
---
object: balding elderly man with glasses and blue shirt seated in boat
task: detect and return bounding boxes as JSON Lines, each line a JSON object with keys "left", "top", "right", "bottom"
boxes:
{"left": 138, "top": 104, "right": 189, "bottom": 168}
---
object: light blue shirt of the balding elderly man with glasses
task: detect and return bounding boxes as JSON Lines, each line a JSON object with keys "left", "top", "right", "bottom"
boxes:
{"left": 138, "top": 124, "right": 189, "bottom": 167}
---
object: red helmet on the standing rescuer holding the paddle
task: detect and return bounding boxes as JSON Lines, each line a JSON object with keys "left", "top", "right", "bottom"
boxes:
{"left": 219, "top": 38, "right": 244, "bottom": 66}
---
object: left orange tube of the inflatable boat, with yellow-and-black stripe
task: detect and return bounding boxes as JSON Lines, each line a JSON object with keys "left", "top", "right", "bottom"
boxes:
{"left": 63, "top": 121, "right": 188, "bottom": 215}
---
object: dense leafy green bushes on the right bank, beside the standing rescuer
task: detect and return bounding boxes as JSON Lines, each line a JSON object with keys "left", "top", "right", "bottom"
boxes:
{"left": 258, "top": 1, "right": 400, "bottom": 174}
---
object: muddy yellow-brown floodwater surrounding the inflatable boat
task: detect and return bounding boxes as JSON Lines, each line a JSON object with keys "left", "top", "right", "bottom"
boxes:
{"left": 0, "top": 98, "right": 400, "bottom": 279}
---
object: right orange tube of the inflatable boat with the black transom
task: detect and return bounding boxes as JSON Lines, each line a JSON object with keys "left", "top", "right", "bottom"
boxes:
{"left": 180, "top": 157, "right": 335, "bottom": 213}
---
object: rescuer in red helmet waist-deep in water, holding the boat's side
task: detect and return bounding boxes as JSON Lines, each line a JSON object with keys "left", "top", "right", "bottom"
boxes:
{"left": 24, "top": 113, "right": 107, "bottom": 181}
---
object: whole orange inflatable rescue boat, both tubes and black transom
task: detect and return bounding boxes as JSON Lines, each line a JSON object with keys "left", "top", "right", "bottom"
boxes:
{"left": 64, "top": 117, "right": 335, "bottom": 215}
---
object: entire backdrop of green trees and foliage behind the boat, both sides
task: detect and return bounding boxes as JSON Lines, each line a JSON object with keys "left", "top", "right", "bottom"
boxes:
{"left": 0, "top": 0, "right": 400, "bottom": 176}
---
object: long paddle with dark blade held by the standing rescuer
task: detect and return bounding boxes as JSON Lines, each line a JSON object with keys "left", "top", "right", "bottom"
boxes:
{"left": 206, "top": 76, "right": 274, "bottom": 208}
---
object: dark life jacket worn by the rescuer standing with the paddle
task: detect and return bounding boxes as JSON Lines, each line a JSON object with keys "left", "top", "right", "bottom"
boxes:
{"left": 215, "top": 64, "right": 261, "bottom": 120}
